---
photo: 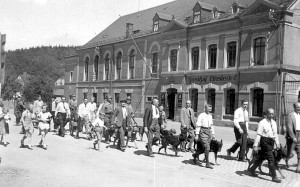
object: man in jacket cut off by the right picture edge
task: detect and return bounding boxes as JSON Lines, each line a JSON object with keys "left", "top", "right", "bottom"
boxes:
{"left": 286, "top": 102, "right": 300, "bottom": 173}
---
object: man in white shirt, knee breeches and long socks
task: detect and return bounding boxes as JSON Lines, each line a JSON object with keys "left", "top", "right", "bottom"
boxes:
{"left": 193, "top": 105, "right": 215, "bottom": 169}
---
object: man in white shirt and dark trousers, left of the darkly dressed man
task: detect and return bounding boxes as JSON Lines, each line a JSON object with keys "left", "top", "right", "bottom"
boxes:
{"left": 55, "top": 96, "right": 71, "bottom": 137}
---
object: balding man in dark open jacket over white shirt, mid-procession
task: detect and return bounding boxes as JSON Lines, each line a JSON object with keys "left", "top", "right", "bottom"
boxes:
{"left": 143, "top": 99, "right": 160, "bottom": 157}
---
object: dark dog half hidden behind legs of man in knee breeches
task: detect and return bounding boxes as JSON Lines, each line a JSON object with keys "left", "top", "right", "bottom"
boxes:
{"left": 193, "top": 139, "right": 223, "bottom": 165}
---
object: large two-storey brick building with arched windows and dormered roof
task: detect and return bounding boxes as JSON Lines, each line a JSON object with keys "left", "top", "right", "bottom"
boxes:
{"left": 65, "top": 0, "right": 300, "bottom": 129}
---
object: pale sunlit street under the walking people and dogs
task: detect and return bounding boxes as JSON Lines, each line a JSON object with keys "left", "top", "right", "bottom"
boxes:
{"left": 0, "top": 113, "right": 300, "bottom": 187}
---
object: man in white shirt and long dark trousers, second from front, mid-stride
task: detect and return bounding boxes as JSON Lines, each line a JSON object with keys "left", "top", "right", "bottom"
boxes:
{"left": 227, "top": 100, "right": 249, "bottom": 162}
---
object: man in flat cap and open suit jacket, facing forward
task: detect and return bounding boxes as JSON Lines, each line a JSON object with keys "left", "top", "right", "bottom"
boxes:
{"left": 112, "top": 99, "right": 131, "bottom": 151}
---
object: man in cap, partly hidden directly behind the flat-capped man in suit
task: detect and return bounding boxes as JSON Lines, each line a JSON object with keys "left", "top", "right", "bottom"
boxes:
{"left": 97, "top": 95, "right": 114, "bottom": 143}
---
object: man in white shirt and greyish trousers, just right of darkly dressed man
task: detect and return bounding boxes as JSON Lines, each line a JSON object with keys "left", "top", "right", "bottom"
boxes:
{"left": 75, "top": 98, "right": 91, "bottom": 139}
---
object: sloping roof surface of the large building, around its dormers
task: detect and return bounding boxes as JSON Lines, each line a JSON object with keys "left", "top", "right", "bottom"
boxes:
{"left": 83, "top": 0, "right": 294, "bottom": 48}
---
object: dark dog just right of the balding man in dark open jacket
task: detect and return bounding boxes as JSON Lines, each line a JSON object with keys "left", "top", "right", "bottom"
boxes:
{"left": 158, "top": 129, "right": 181, "bottom": 156}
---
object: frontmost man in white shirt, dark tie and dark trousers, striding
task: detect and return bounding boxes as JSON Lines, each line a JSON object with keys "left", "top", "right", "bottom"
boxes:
{"left": 248, "top": 108, "right": 281, "bottom": 183}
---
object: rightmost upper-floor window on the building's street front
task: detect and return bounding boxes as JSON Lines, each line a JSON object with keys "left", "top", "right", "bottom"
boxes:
{"left": 253, "top": 37, "right": 266, "bottom": 65}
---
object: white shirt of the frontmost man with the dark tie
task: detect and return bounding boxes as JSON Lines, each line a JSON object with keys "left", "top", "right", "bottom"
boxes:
{"left": 254, "top": 118, "right": 279, "bottom": 146}
